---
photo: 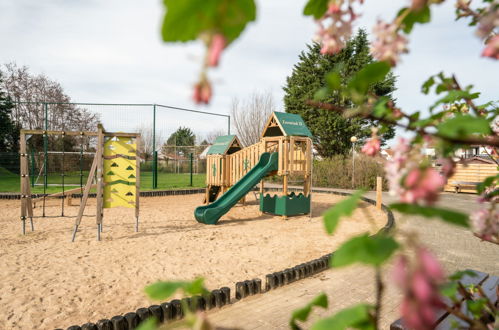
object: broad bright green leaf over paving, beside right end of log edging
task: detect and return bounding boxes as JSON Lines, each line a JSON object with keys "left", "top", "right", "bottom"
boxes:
{"left": 331, "top": 234, "right": 399, "bottom": 267}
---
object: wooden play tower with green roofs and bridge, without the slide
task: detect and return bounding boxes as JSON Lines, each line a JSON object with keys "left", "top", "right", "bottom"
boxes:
{"left": 205, "top": 112, "right": 312, "bottom": 217}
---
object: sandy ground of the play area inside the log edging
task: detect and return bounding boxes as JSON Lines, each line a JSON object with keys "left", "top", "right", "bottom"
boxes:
{"left": 0, "top": 194, "right": 386, "bottom": 329}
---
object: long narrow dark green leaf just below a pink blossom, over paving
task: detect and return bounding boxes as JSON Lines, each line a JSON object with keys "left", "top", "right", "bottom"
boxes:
{"left": 390, "top": 203, "right": 469, "bottom": 228}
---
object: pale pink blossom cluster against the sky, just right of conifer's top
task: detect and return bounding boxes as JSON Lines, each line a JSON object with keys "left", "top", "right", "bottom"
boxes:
{"left": 371, "top": 20, "right": 409, "bottom": 66}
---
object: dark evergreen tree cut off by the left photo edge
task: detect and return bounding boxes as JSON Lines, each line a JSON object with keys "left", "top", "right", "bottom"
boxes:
{"left": 0, "top": 72, "right": 19, "bottom": 153}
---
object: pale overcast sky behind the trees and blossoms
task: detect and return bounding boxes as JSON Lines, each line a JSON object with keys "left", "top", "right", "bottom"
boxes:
{"left": 0, "top": 0, "right": 499, "bottom": 141}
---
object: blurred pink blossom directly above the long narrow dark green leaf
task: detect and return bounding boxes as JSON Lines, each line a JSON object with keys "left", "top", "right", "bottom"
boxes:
{"left": 401, "top": 167, "right": 445, "bottom": 204}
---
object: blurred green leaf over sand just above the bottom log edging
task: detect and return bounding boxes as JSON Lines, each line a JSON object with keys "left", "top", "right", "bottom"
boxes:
{"left": 144, "top": 278, "right": 207, "bottom": 300}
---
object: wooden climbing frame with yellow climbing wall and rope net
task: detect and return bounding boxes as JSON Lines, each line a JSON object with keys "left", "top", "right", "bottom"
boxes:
{"left": 20, "top": 125, "right": 140, "bottom": 241}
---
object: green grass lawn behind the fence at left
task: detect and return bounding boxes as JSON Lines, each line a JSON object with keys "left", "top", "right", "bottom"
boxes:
{"left": 0, "top": 172, "right": 206, "bottom": 194}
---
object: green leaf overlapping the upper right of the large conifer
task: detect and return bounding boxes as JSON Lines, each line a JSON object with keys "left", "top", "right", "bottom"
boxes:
{"left": 347, "top": 62, "right": 390, "bottom": 103}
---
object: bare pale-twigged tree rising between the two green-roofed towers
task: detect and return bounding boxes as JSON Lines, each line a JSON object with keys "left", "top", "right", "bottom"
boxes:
{"left": 230, "top": 91, "right": 275, "bottom": 147}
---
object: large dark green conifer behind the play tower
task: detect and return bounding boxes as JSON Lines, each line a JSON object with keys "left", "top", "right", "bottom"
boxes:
{"left": 284, "top": 30, "right": 395, "bottom": 157}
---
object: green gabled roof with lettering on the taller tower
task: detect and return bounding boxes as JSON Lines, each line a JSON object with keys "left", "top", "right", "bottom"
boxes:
{"left": 262, "top": 112, "right": 312, "bottom": 138}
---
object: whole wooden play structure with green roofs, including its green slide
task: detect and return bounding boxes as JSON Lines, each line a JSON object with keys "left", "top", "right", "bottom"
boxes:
{"left": 194, "top": 112, "right": 312, "bottom": 224}
